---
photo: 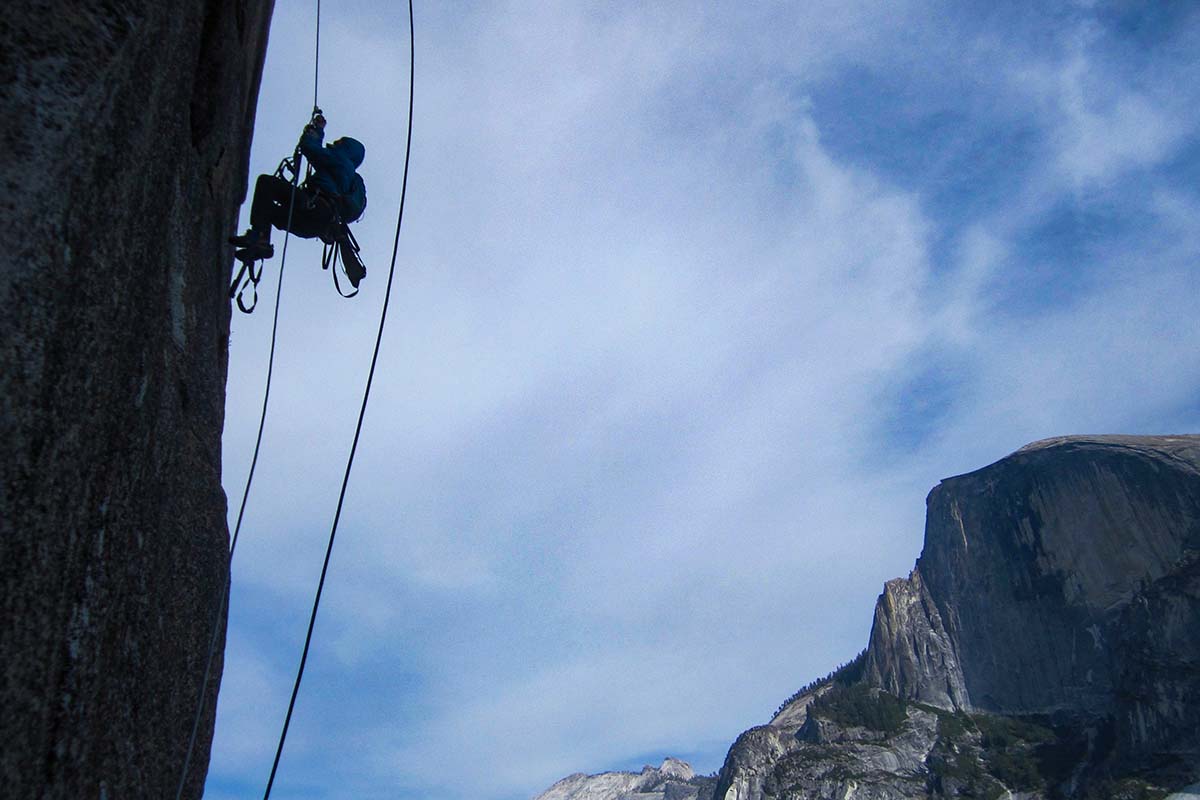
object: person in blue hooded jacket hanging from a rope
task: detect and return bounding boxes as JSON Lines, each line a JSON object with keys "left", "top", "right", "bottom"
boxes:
{"left": 229, "top": 109, "right": 367, "bottom": 287}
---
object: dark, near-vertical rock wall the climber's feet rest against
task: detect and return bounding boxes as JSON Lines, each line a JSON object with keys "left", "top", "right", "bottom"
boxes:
{"left": 0, "top": 0, "right": 272, "bottom": 799}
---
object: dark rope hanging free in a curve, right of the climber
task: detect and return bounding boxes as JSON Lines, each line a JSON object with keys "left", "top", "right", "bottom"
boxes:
{"left": 263, "top": 0, "right": 416, "bottom": 800}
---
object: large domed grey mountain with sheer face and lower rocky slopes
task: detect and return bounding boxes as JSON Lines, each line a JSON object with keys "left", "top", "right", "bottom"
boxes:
{"left": 715, "top": 435, "right": 1200, "bottom": 800}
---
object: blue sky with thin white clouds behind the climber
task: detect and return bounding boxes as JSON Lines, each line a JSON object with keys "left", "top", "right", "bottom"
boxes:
{"left": 205, "top": 0, "right": 1200, "bottom": 800}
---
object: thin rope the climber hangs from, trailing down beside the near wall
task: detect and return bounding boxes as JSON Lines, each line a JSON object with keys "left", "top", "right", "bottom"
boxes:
{"left": 175, "top": 0, "right": 320, "bottom": 800}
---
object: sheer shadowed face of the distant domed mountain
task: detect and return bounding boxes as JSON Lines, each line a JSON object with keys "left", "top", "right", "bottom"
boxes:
{"left": 902, "top": 437, "right": 1200, "bottom": 751}
